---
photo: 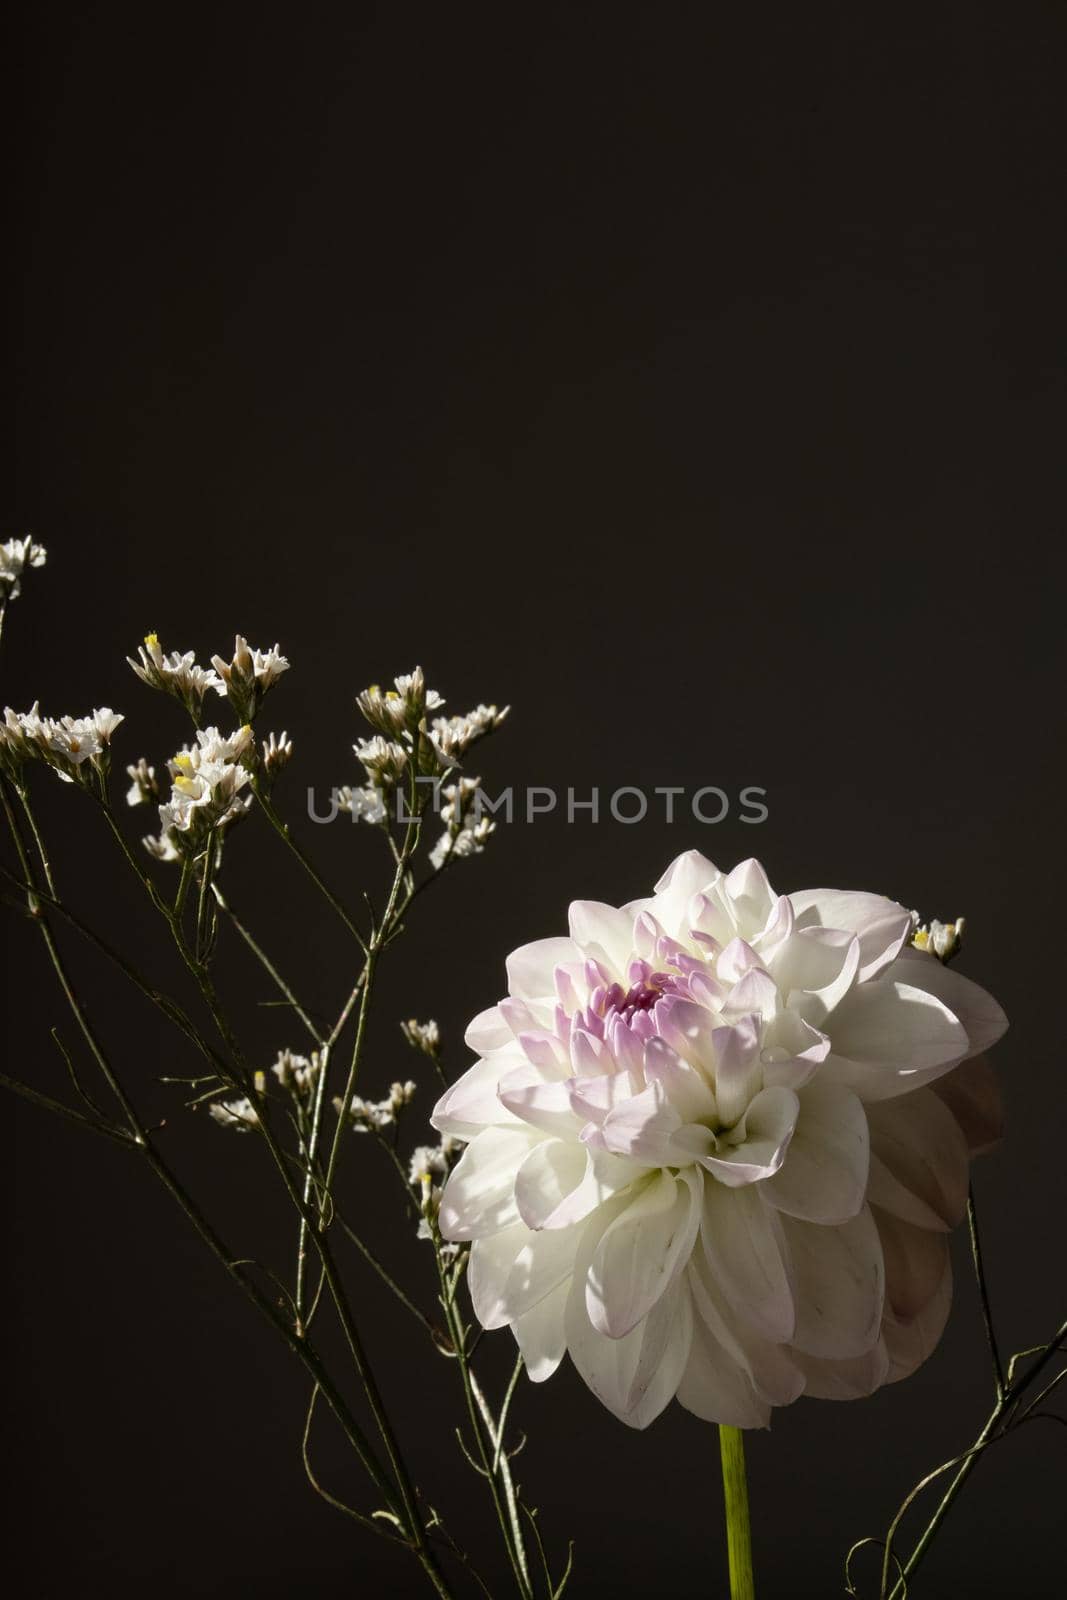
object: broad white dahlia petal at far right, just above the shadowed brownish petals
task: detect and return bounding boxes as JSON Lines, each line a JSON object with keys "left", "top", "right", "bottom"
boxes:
{"left": 822, "top": 963, "right": 969, "bottom": 1101}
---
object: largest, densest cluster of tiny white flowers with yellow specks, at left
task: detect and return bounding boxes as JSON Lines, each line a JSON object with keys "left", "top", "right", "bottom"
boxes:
{"left": 144, "top": 725, "right": 254, "bottom": 861}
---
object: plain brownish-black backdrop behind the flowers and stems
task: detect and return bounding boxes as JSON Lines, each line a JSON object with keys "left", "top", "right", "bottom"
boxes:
{"left": 2, "top": 3, "right": 1067, "bottom": 1600}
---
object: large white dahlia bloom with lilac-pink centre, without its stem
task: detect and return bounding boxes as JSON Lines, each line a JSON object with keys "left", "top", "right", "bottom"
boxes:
{"left": 432, "top": 851, "right": 1006, "bottom": 1427}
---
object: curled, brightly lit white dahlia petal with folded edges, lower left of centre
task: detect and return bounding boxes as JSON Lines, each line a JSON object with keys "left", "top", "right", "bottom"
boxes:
{"left": 585, "top": 1171, "right": 701, "bottom": 1339}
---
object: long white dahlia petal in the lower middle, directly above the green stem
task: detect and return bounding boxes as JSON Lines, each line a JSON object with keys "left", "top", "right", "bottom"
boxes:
{"left": 701, "top": 1182, "right": 797, "bottom": 1344}
